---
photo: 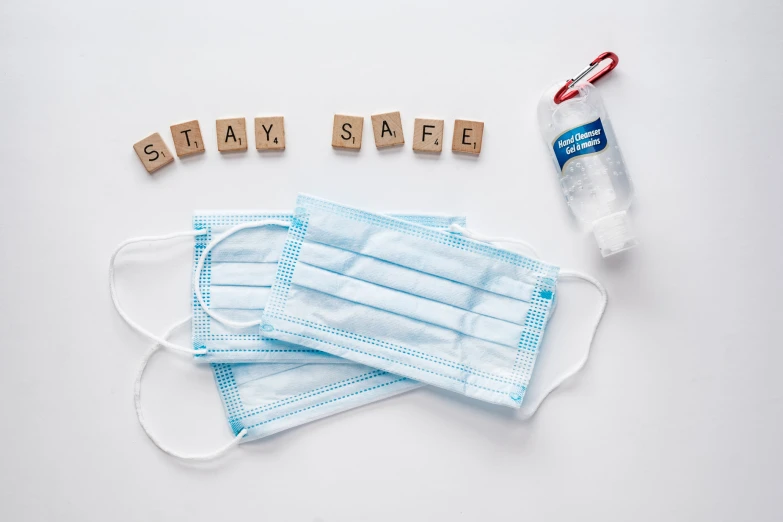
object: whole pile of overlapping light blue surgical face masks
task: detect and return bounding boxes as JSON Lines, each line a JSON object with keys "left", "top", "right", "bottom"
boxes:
{"left": 116, "top": 196, "right": 607, "bottom": 459}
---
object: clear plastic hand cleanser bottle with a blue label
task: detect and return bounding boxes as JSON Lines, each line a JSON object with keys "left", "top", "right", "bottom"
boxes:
{"left": 538, "top": 82, "right": 638, "bottom": 257}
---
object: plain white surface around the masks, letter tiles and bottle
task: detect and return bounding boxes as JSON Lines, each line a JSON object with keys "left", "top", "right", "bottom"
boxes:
{"left": 0, "top": 0, "right": 783, "bottom": 521}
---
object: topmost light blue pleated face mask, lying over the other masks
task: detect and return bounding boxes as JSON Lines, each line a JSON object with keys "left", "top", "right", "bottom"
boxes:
{"left": 261, "top": 196, "right": 606, "bottom": 414}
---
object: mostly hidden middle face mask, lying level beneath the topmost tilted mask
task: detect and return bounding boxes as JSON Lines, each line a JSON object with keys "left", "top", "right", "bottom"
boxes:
{"left": 192, "top": 211, "right": 465, "bottom": 364}
